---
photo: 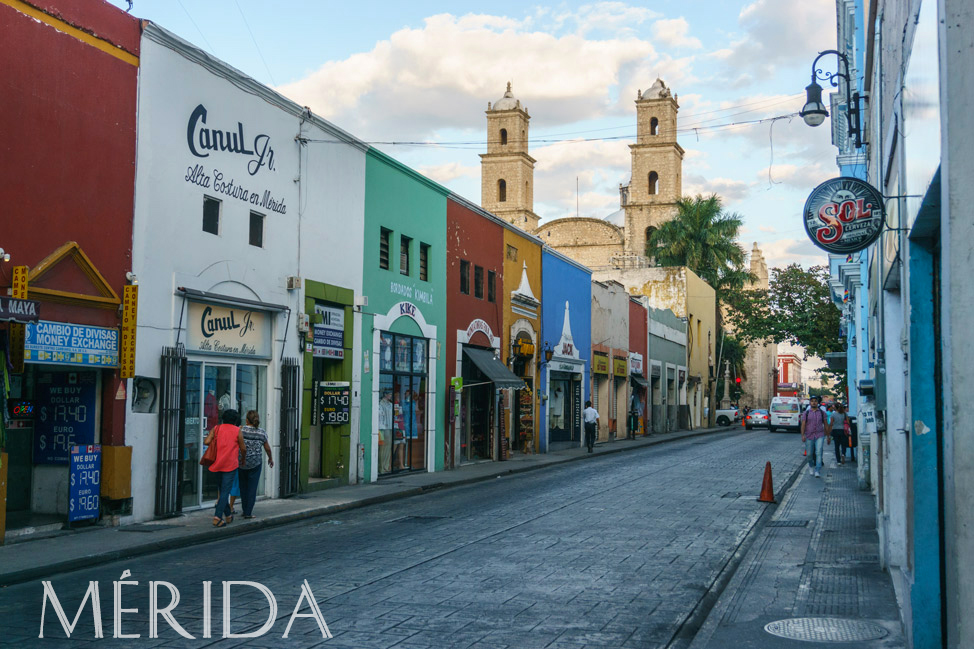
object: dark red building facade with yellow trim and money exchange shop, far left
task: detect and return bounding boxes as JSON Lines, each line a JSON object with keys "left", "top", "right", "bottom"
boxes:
{"left": 0, "top": 0, "right": 141, "bottom": 523}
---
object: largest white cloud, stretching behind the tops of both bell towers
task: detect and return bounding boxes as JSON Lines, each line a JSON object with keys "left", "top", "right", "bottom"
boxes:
{"left": 280, "top": 13, "right": 664, "bottom": 140}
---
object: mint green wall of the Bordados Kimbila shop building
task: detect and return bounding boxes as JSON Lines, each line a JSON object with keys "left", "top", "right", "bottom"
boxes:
{"left": 361, "top": 149, "right": 449, "bottom": 479}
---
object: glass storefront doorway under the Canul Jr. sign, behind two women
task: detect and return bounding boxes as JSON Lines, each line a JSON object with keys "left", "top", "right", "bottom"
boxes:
{"left": 182, "top": 360, "right": 268, "bottom": 509}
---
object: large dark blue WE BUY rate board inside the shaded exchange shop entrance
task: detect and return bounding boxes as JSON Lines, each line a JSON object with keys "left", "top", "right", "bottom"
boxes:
{"left": 34, "top": 371, "right": 97, "bottom": 464}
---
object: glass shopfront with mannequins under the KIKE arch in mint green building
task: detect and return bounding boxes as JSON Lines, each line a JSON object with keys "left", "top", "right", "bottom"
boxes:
{"left": 379, "top": 332, "right": 429, "bottom": 475}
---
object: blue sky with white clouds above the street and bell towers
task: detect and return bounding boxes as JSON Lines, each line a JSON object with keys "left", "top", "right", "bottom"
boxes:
{"left": 112, "top": 0, "right": 839, "bottom": 267}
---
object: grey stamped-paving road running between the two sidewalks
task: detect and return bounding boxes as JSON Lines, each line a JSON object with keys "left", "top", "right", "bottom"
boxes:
{"left": 0, "top": 430, "right": 802, "bottom": 649}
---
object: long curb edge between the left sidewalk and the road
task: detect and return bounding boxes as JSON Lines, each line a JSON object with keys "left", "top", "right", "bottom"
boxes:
{"left": 0, "top": 426, "right": 744, "bottom": 588}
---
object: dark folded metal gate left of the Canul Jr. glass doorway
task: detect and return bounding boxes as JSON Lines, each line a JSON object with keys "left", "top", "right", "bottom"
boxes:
{"left": 156, "top": 345, "right": 188, "bottom": 517}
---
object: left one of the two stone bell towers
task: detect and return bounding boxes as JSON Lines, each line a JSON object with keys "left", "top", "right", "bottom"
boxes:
{"left": 480, "top": 82, "right": 540, "bottom": 232}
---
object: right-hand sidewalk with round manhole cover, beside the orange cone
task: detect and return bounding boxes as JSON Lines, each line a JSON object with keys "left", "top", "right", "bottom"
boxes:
{"left": 690, "top": 447, "right": 906, "bottom": 649}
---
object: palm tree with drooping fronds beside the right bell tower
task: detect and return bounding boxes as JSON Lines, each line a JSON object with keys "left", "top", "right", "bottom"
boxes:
{"left": 646, "top": 194, "right": 755, "bottom": 300}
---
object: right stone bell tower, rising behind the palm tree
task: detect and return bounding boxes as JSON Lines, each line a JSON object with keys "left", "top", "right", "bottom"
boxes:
{"left": 620, "top": 78, "right": 684, "bottom": 255}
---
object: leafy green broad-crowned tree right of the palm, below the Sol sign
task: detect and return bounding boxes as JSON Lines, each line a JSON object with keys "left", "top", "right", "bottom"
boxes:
{"left": 726, "top": 264, "right": 844, "bottom": 358}
